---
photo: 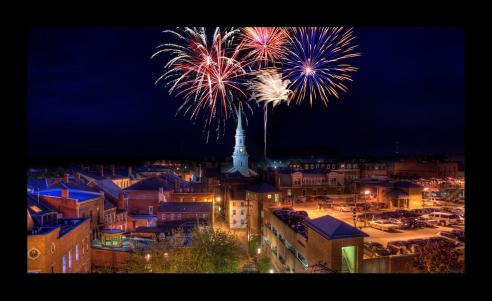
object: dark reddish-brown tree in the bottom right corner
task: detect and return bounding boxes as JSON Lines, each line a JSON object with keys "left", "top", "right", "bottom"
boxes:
{"left": 415, "top": 240, "right": 464, "bottom": 273}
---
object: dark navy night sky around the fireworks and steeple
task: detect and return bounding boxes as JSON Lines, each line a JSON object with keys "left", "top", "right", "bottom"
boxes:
{"left": 28, "top": 27, "right": 464, "bottom": 158}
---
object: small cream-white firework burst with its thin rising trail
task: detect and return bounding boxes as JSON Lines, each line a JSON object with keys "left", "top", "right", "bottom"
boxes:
{"left": 248, "top": 68, "right": 292, "bottom": 159}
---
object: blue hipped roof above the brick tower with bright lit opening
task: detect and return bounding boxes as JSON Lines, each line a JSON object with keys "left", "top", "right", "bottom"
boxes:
{"left": 304, "top": 215, "right": 369, "bottom": 239}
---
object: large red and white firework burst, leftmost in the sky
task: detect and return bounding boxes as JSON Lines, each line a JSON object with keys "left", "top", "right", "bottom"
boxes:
{"left": 151, "top": 27, "right": 251, "bottom": 142}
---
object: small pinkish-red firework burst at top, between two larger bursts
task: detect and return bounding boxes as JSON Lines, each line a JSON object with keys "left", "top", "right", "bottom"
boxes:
{"left": 241, "top": 27, "right": 287, "bottom": 66}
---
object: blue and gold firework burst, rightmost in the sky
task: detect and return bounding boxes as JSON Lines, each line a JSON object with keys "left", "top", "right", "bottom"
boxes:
{"left": 282, "top": 27, "right": 361, "bottom": 106}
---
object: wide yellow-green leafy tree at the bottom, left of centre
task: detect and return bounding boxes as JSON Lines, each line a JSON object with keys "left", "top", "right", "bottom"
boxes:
{"left": 125, "top": 228, "right": 241, "bottom": 273}
